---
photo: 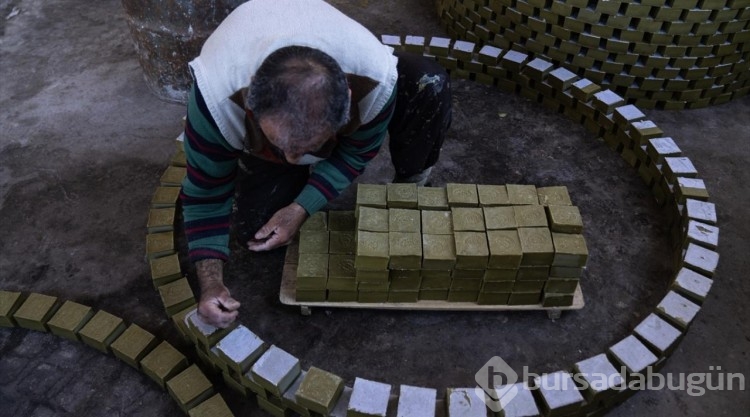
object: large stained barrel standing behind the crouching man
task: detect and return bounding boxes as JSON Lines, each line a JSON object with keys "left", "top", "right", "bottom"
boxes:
{"left": 122, "top": 0, "right": 246, "bottom": 103}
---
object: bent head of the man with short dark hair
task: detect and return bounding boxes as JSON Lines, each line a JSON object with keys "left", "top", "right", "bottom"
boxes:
{"left": 245, "top": 45, "right": 350, "bottom": 150}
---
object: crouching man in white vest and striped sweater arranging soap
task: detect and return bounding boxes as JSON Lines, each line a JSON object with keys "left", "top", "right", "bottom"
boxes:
{"left": 180, "top": 0, "right": 450, "bottom": 327}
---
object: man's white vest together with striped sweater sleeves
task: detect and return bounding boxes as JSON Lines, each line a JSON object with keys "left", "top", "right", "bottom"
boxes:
{"left": 181, "top": 0, "right": 398, "bottom": 261}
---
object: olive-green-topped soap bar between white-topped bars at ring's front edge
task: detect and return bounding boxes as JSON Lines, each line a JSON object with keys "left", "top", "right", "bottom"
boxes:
{"left": 295, "top": 366, "right": 344, "bottom": 415}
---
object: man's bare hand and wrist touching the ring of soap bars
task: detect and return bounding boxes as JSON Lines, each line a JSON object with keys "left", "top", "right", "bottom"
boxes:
{"left": 195, "top": 259, "right": 240, "bottom": 328}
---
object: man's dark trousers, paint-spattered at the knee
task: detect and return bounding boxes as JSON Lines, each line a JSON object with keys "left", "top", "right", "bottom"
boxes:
{"left": 235, "top": 52, "right": 451, "bottom": 240}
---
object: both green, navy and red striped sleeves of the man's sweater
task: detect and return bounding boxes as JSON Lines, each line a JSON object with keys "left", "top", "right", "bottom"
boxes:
{"left": 180, "top": 85, "right": 396, "bottom": 262}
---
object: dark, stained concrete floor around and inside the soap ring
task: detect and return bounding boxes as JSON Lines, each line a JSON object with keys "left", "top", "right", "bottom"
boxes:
{"left": 0, "top": 0, "right": 750, "bottom": 417}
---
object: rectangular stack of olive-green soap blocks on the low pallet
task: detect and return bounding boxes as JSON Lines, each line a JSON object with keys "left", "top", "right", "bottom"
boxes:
{"left": 297, "top": 184, "right": 588, "bottom": 307}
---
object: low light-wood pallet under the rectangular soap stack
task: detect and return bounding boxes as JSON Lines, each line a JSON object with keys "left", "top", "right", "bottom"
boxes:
{"left": 279, "top": 241, "right": 584, "bottom": 320}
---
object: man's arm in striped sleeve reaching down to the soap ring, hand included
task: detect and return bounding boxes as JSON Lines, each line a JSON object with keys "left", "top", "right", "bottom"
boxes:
{"left": 180, "top": 86, "right": 240, "bottom": 327}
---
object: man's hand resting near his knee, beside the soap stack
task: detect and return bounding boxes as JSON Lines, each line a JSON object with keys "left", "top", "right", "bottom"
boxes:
{"left": 247, "top": 203, "right": 307, "bottom": 252}
